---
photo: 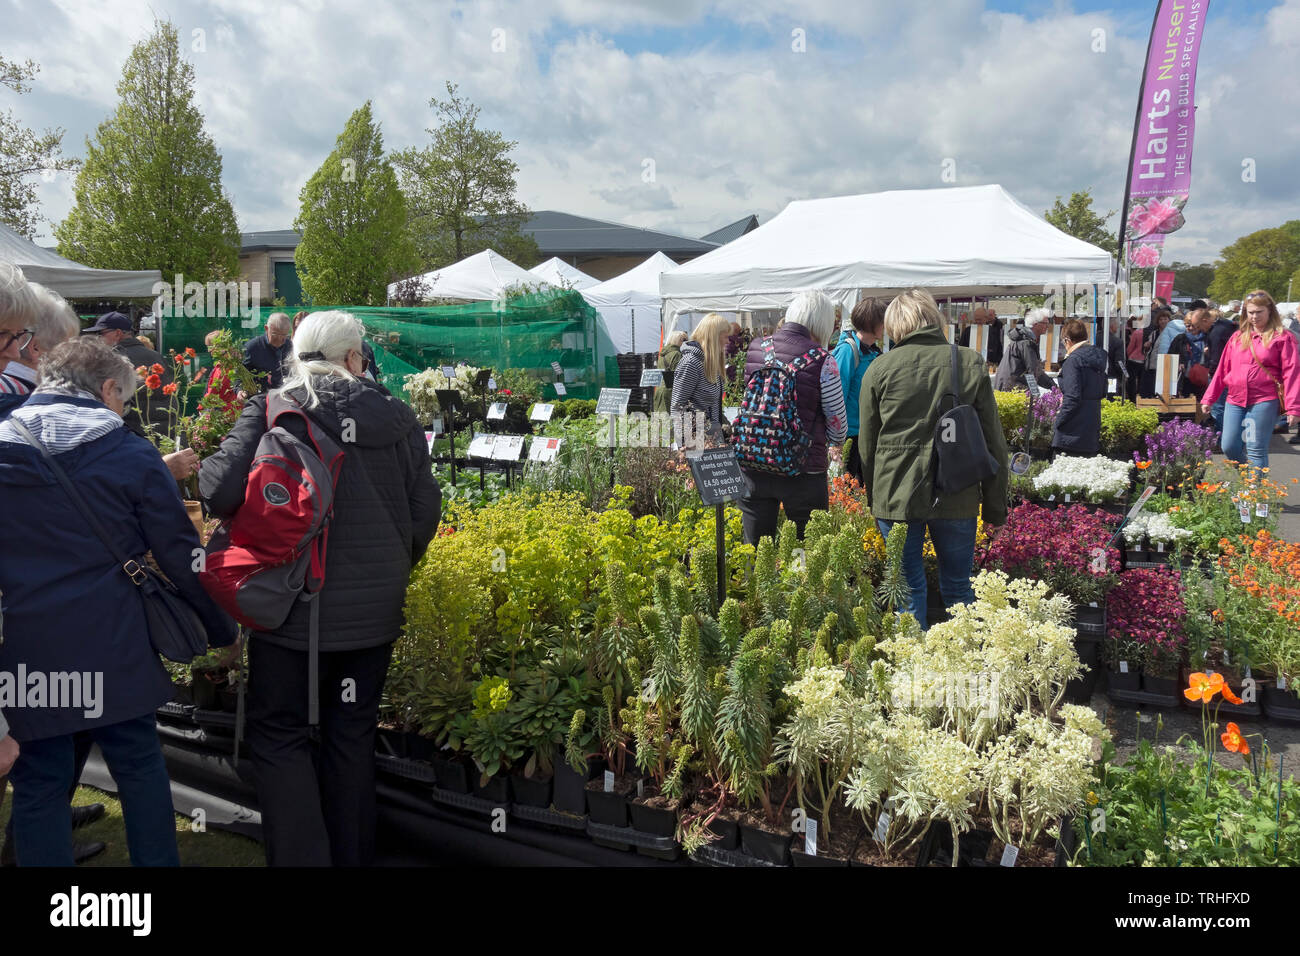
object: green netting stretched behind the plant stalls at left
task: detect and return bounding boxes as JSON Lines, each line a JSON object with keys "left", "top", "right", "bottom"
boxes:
{"left": 150, "top": 291, "right": 599, "bottom": 398}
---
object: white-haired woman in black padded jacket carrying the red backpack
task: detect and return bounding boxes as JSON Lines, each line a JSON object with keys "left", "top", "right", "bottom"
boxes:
{"left": 199, "top": 311, "right": 442, "bottom": 866}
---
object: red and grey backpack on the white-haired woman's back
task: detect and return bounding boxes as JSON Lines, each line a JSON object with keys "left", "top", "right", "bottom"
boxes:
{"left": 198, "top": 392, "right": 343, "bottom": 723}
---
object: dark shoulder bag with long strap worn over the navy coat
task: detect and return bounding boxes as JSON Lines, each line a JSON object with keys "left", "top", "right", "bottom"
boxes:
{"left": 9, "top": 418, "right": 208, "bottom": 663}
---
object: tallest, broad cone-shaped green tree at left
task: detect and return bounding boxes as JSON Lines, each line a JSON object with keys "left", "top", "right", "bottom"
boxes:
{"left": 55, "top": 21, "right": 239, "bottom": 282}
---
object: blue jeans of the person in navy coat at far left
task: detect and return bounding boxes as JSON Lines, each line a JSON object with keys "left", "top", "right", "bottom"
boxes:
{"left": 9, "top": 713, "right": 181, "bottom": 866}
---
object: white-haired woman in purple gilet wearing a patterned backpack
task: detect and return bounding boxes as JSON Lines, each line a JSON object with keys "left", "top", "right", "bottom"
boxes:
{"left": 733, "top": 291, "right": 848, "bottom": 544}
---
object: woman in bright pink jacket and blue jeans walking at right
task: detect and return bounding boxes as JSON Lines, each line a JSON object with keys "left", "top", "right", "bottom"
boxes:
{"left": 1201, "top": 289, "right": 1300, "bottom": 468}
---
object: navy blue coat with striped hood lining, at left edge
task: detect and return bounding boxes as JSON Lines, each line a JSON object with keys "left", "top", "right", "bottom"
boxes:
{"left": 0, "top": 393, "right": 235, "bottom": 743}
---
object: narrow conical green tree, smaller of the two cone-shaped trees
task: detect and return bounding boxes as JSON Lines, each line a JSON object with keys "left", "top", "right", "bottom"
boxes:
{"left": 294, "top": 100, "right": 416, "bottom": 306}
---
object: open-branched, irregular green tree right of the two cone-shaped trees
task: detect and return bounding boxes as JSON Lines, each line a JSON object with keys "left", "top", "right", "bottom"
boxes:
{"left": 393, "top": 83, "right": 541, "bottom": 269}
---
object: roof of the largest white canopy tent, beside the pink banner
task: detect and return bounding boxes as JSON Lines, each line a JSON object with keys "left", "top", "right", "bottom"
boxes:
{"left": 659, "top": 185, "right": 1113, "bottom": 329}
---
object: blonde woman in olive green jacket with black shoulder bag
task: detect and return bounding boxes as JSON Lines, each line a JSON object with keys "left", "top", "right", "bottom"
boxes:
{"left": 858, "top": 289, "right": 1008, "bottom": 627}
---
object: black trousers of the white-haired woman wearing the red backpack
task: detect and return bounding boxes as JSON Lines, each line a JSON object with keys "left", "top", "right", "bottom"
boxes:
{"left": 247, "top": 637, "right": 393, "bottom": 866}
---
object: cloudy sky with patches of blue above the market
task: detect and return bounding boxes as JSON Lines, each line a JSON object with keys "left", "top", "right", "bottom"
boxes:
{"left": 0, "top": 0, "right": 1300, "bottom": 261}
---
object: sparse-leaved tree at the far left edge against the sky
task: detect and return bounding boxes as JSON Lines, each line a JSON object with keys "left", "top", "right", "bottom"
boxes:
{"left": 0, "top": 56, "right": 81, "bottom": 239}
